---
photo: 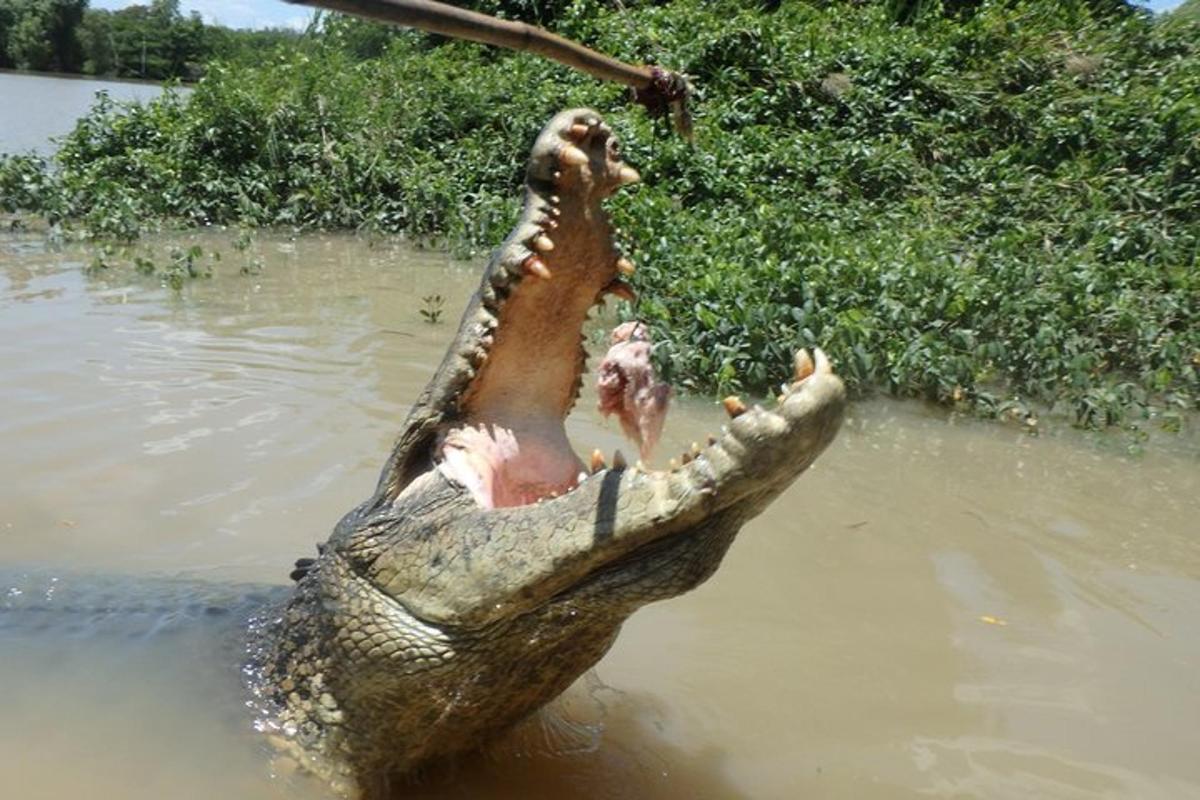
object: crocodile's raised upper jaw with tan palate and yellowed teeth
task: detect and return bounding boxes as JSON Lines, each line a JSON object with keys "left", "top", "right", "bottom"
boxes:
{"left": 377, "top": 109, "right": 640, "bottom": 500}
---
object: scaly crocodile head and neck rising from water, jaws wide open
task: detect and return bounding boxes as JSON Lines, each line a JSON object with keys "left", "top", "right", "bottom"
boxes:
{"left": 259, "top": 109, "right": 845, "bottom": 787}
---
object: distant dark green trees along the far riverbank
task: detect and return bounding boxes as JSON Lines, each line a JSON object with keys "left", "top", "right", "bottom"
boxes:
{"left": 0, "top": 0, "right": 299, "bottom": 80}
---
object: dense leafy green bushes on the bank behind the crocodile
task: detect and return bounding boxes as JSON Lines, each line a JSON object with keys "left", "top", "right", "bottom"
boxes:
{"left": 0, "top": 0, "right": 1200, "bottom": 426}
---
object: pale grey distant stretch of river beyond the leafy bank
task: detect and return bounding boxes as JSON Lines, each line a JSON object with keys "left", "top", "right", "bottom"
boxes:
{"left": 0, "top": 71, "right": 177, "bottom": 156}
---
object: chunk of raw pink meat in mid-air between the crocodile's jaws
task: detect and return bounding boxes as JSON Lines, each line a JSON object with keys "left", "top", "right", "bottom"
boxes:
{"left": 596, "top": 323, "right": 671, "bottom": 458}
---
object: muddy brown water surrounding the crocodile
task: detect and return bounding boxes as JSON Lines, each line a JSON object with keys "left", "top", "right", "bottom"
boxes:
{"left": 0, "top": 235, "right": 1200, "bottom": 800}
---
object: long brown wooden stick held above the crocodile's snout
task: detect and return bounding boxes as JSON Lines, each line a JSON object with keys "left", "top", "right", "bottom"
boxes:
{"left": 287, "top": 0, "right": 690, "bottom": 136}
